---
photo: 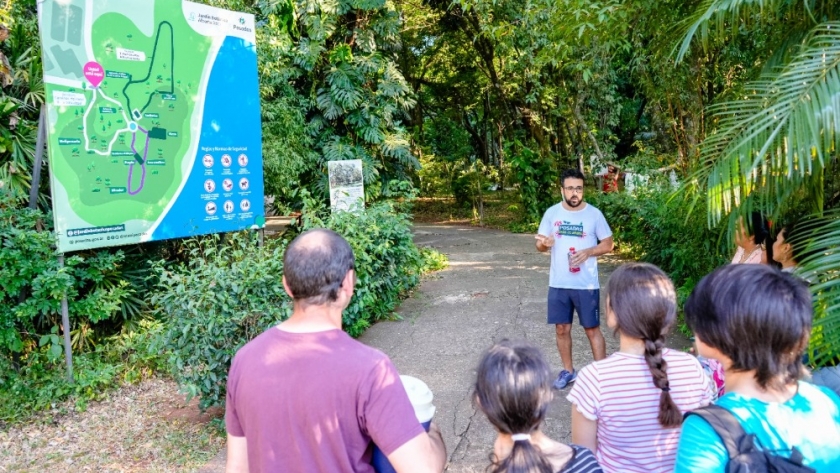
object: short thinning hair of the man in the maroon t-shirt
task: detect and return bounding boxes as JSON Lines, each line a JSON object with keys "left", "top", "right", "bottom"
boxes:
{"left": 283, "top": 228, "right": 355, "bottom": 305}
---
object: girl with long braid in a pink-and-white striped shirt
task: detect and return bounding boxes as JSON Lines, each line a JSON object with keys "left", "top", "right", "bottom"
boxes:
{"left": 568, "top": 263, "right": 713, "bottom": 473}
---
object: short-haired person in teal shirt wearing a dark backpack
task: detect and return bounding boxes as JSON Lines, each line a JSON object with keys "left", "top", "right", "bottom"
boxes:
{"left": 676, "top": 265, "right": 840, "bottom": 473}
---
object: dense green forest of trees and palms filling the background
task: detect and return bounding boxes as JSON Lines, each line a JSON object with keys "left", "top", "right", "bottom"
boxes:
{"left": 0, "top": 0, "right": 840, "bottom": 420}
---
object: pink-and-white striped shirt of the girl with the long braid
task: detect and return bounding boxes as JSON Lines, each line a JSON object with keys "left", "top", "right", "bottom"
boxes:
{"left": 567, "top": 348, "right": 714, "bottom": 473}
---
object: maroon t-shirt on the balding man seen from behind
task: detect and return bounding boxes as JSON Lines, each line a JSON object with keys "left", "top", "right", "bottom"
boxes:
{"left": 225, "top": 327, "right": 425, "bottom": 473}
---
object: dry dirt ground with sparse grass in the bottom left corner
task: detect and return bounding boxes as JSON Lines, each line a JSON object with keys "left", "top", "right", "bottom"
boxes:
{"left": 0, "top": 379, "right": 224, "bottom": 473}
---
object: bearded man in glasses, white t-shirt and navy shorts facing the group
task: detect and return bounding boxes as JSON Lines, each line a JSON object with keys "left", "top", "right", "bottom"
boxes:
{"left": 536, "top": 169, "right": 613, "bottom": 389}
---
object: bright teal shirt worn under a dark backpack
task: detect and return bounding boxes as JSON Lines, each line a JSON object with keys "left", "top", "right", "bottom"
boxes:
{"left": 674, "top": 381, "right": 840, "bottom": 473}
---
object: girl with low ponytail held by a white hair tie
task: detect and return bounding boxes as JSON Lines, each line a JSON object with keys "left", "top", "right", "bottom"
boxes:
{"left": 473, "top": 340, "right": 601, "bottom": 473}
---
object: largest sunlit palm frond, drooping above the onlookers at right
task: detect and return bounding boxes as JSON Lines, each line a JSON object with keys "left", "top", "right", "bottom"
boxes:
{"left": 700, "top": 23, "right": 840, "bottom": 223}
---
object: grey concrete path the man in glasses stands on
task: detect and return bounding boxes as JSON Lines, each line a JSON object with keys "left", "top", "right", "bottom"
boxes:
{"left": 360, "top": 225, "right": 622, "bottom": 473}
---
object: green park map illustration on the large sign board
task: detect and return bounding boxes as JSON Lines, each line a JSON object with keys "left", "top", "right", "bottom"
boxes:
{"left": 42, "top": 1, "right": 212, "bottom": 226}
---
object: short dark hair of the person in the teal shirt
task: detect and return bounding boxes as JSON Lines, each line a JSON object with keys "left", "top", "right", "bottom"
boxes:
{"left": 685, "top": 264, "right": 814, "bottom": 389}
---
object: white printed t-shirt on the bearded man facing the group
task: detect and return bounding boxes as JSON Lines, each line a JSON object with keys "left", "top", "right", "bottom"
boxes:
{"left": 539, "top": 202, "right": 612, "bottom": 289}
